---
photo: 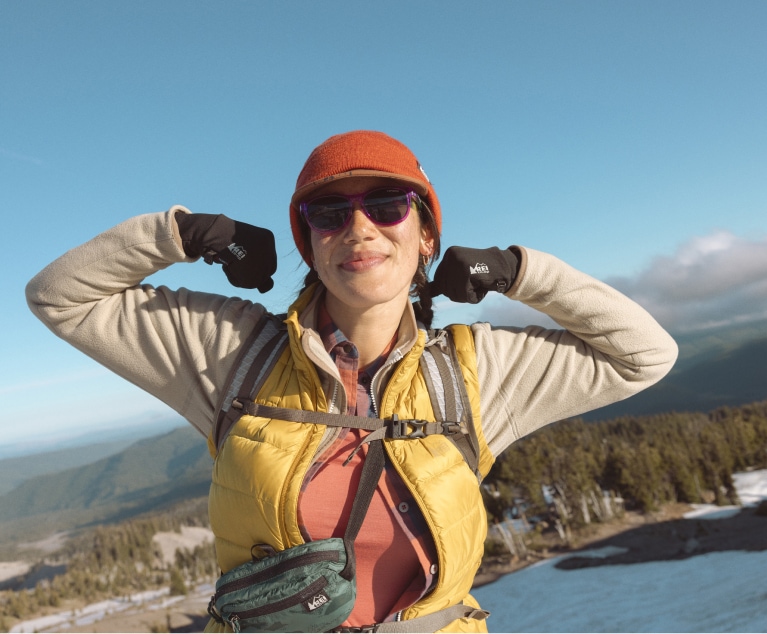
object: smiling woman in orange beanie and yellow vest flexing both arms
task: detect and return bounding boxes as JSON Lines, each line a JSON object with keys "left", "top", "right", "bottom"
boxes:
{"left": 27, "top": 131, "right": 676, "bottom": 631}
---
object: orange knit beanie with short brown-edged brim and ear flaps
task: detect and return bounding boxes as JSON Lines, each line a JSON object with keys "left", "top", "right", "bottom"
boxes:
{"left": 290, "top": 130, "right": 442, "bottom": 266}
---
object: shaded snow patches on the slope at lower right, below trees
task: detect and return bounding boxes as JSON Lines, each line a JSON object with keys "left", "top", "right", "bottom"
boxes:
{"left": 472, "top": 470, "right": 767, "bottom": 632}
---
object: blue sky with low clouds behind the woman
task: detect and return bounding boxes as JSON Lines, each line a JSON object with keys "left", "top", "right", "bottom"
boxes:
{"left": 0, "top": 0, "right": 767, "bottom": 452}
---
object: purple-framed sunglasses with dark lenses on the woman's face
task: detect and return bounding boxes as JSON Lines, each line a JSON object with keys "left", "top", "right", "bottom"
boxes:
{"left": 300, "top": 187, "right": 421, "bottom": 233}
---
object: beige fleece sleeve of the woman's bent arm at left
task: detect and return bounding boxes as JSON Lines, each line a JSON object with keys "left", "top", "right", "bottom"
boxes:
{"left": 26, "top": 206, "right": 264, "bottom": 435}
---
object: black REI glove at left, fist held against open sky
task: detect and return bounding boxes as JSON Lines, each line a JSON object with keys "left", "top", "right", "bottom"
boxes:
{"left": 176, "top": 211, "right": 277, "bottom": 293}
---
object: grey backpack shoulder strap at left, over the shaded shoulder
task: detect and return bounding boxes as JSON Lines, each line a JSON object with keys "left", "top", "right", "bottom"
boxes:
{"left": 212, "top": 312, "right": 288, "bottom": 451}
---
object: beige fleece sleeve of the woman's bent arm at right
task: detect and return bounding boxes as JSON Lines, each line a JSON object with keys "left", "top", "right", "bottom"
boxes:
{"left": 472, "top": 244, "right": 677, "bottom": 456}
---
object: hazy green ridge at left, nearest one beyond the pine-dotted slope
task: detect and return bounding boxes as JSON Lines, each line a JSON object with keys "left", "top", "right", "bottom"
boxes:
{"left": 0, "top": 428, "right": 212, "bottom": 545}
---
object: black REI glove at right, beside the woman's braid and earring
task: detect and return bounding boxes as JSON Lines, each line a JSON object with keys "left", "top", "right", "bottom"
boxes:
{"left": 429, "top": 247, "right": 519, "bottom": 304}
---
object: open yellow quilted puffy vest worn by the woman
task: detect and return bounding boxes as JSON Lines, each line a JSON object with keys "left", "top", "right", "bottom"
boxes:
{"left": 209, "top": 297, "right": 494, "bottom": 632}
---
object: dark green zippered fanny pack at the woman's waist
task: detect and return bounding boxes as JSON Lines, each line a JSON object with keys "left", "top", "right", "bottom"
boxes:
{"left": 208, "top": 537, "right": 357, "bottom": 632}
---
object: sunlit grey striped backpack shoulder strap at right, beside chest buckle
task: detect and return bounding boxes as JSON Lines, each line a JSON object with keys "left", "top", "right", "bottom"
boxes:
{"left": 420, "top": 330, "right": 482, "bottom": 480}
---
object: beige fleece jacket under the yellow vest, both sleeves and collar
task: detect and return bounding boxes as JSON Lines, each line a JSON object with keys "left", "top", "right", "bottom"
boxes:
{"left": 26, "top": 206, "right": 677, "bottom": 456}
